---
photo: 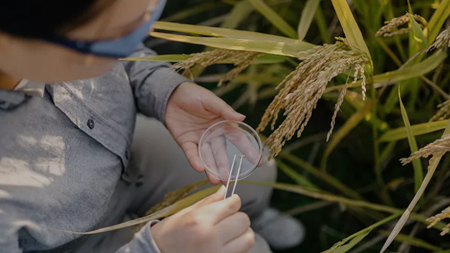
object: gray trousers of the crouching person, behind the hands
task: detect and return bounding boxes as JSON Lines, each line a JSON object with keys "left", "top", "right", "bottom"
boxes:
{"left": 78, "top": 116, "right": 276, "bottom": 253}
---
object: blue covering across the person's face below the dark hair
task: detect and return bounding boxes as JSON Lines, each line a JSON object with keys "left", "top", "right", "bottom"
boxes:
{"left": 45, "top": 0, "right": 166, "bottom": 58}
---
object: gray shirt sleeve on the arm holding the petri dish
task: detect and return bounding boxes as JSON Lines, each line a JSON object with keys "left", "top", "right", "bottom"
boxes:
{"left": 123, "top": 44, "right": 191, "bottom": 124}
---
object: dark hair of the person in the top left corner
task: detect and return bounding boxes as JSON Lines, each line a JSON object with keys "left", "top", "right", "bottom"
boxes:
{"left": 0, "top": 0, "right": 113, "bottom": 38}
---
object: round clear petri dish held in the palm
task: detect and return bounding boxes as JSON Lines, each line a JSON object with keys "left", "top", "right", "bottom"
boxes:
{"left": 198, "top": 120, "right": 263, "bottom": 182}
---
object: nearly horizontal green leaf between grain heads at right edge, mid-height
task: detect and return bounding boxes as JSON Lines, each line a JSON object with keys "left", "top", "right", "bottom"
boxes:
{"left": 380, "top": 120, "right": 449, "bottom": 142}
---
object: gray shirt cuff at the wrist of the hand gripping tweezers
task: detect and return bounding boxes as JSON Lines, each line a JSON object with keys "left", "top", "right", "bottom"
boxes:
{"left": 116, "top": 221, "right": 161, "bottom": 253}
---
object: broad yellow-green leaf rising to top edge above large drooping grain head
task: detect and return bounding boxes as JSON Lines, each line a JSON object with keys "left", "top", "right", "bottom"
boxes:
{"left": 331, "top": 0, "right": 370, "bottom": 58}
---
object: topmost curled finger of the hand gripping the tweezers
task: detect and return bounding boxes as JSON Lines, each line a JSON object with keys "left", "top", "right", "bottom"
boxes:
{"left": 201, "top": 194, "right": 242, "bottom": 224}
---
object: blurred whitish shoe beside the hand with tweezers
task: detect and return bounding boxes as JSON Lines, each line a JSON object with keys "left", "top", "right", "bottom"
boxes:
{"left": 252, "top": 208, "right": 305, "bottom": 250}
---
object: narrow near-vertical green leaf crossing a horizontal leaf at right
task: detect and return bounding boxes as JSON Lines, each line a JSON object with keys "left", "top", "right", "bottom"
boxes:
{"left": 398, "top": 86, "right": 423, "bottom": 192}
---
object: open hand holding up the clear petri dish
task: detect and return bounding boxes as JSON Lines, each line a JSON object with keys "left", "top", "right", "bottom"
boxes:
{"left": 165, "top": 83, "right": 245, "bottom": 184}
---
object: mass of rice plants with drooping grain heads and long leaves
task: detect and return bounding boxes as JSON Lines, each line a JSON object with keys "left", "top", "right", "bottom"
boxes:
{"left": 115, "top": 0, "right": 450, "bottom": 252}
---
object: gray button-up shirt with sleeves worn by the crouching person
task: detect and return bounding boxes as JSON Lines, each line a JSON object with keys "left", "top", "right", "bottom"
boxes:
{"left": 0, "top": 45, "right": 189, "bottom": 253}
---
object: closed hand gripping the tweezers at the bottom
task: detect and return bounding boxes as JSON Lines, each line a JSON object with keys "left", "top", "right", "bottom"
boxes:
{"left": 151, "top": 186, "right": 255, "bottom": 253}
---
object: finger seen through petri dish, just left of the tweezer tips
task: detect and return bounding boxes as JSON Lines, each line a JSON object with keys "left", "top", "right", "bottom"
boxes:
{"left": 211, "top": 136, "right": 230, "bottom": 181}
